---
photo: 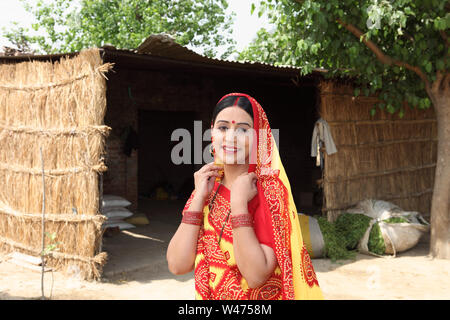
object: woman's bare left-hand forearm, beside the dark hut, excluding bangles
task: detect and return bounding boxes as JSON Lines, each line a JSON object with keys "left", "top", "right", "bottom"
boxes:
{"left": 167, "top": 196, "right": 204, "bottom": 275}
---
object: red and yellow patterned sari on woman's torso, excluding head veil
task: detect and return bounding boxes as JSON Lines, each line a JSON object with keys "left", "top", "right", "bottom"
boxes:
{"left": 183, "top": 182, "right": 283, "bottom": 300}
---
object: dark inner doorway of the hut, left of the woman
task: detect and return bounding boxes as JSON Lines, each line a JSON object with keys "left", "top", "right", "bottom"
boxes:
{"left": 138, "top": 110, "right": 195, "bottom": 224}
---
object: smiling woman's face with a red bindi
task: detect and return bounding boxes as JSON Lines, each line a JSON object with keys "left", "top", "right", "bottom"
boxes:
{"left": 211, "top": 107, "right": 253, "bottom": 164}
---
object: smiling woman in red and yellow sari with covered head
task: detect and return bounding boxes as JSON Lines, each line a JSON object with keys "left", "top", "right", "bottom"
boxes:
{"left": 167, "top": 93, "right": 322, "bottom": 300}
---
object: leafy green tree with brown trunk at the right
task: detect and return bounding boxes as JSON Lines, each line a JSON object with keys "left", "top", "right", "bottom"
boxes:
{"left": 243, "top": 0, "right": 450, "bottom": 259}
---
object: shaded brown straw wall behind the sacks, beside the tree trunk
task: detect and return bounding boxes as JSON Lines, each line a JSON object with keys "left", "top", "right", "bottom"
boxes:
{"left": 320, "top": 81, "right": 437, "bottom": 221}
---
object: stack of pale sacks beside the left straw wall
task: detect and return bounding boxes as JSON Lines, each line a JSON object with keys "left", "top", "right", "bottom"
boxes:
{"left": 101, "top": 194, "right": 136, "bottom": 230}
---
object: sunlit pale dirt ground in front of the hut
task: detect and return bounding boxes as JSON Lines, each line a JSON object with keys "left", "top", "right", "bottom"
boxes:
{"left": 0, "top": 235, "right": 450, "bottom": 300}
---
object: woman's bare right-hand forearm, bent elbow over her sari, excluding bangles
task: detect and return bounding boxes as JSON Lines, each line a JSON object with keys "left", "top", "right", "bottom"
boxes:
{"left": 231, "top": 202, "right": 277, "bottom": 288}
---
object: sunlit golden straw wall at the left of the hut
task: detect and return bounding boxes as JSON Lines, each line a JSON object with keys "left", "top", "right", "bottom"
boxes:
{"left": 0, "top": 49, "right": 111, "bottom": 279}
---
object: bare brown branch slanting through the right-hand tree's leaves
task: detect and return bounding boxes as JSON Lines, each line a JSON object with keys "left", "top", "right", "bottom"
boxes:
{"left": 337, "top": 19, "right": 430, "bottom": 88}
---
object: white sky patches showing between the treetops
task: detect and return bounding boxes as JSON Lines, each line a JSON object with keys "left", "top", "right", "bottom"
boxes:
{"left": 0, "top": 0, "right": 269, "bottom": 57}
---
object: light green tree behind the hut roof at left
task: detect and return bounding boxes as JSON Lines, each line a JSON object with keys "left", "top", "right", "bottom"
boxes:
{"left": 4, "top": 0, "right": 235, "bottom": 58}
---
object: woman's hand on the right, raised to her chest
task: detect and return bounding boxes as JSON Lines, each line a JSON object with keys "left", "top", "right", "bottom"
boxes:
{"left": 230, "top": 172, "right": 258, "bottom": 212}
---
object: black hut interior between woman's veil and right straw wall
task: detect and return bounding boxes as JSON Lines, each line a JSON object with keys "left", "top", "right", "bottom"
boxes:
{"left": 256, "top": 84, "right": 323, "bottom": 215}
